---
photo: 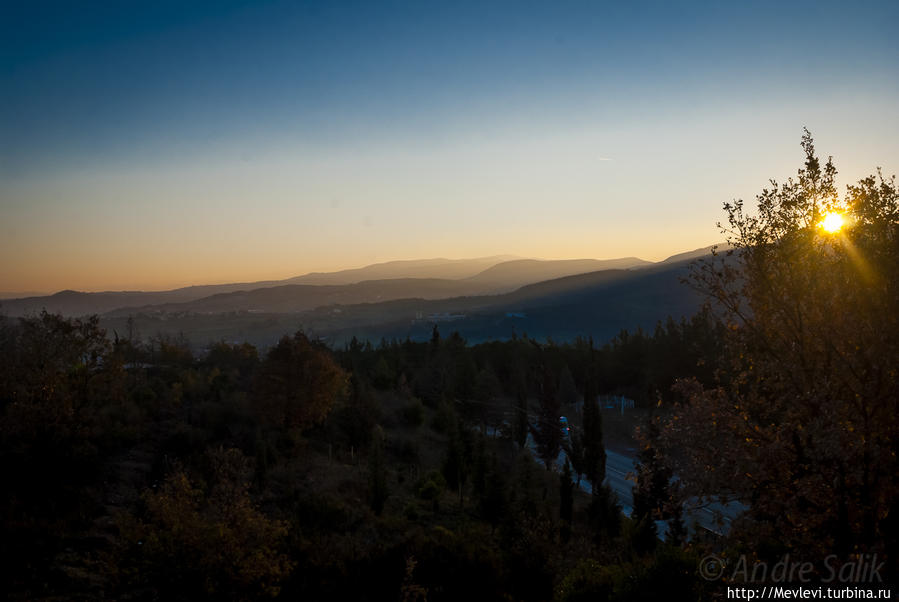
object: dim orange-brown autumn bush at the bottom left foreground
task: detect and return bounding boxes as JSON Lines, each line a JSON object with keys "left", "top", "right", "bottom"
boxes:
{"left": 124, "top": 449, "right": 292, "bottom": 599}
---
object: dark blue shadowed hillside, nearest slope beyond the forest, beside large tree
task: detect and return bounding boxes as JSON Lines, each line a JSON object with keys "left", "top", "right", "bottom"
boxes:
{"left": 303, "top": 255, "right": 702, "bottom": 344}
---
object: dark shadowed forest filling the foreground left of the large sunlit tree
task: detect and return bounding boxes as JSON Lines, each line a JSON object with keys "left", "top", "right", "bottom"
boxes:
{"left": 2, "top": 304, "right": 717, "bottom": 600}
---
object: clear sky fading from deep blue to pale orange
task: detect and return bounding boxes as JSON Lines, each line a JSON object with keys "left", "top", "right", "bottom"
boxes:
{"left": 0, "top": 0, "right": 899, "bottom": 292}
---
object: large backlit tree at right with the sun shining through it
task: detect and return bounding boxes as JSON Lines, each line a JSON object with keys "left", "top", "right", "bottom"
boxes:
{"left": 661, "top": 131, "right": 899, "bottom": 562}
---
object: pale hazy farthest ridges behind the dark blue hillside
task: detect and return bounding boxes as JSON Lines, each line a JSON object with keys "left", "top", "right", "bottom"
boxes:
{"left": 0, "top": 255, "right": 676, "bottom": 316}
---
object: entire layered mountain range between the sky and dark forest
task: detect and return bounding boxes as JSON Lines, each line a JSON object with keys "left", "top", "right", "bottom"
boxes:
{"left": 0, "top": 247, "right": 724, "bottom": 347}
